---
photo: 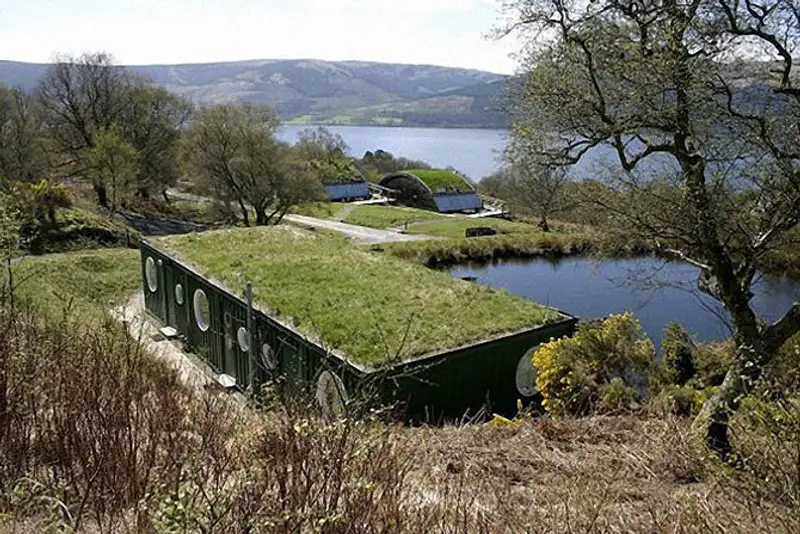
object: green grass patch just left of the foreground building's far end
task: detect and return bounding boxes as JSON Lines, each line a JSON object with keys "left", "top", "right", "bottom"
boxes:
{"left": 3, "top": 249, "right": 141, "bottom": 317}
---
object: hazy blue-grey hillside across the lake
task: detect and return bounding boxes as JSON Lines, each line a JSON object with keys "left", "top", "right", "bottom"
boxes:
{"left": 0, "top": 59, "right": 506, "bottom": 128}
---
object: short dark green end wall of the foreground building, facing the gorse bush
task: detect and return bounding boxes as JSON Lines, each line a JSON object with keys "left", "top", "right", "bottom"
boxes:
{"left": 382, "top": 319, "right": 577, "bottom": 421}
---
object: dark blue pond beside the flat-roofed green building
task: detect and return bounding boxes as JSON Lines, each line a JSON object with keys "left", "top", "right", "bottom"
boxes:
{"left": 450, "top": 257, "right": 800, "bottom": 345}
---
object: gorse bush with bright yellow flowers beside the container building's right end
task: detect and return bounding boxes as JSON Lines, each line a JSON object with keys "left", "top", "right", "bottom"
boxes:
{"left": 533, "top": 313, "right": 657, "bottom": 415}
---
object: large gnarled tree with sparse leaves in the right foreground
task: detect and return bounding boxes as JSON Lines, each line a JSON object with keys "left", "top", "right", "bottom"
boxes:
{"left": 508, "top": 0, "right": 800, "bottom": 458}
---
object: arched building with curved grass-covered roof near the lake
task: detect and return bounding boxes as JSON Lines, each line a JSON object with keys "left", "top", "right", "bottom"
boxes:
{"left": 380, "top": 169, "right": 483, "bottom": 213}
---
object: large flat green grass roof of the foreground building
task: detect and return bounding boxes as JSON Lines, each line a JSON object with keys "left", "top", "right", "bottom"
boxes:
{"left": 155, "top": 227, "right": 563, "bottom": 367}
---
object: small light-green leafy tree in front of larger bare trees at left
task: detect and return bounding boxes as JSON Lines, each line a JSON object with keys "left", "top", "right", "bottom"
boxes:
{"left": 82, "top": 126, "right": 137, "bottom": 211}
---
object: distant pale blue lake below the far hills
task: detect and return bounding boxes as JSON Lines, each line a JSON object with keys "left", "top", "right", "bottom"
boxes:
{"left": 277, "top": 125, "right": 648, "bottom": 181}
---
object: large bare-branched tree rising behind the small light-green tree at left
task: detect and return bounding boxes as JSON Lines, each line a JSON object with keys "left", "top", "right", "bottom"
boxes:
{"left": 38, "top": 53, "right": 191, "bottom": 207}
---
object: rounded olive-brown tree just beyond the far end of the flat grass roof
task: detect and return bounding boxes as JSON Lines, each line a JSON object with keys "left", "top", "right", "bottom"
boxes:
{"left": 182, "top": 103, "right": 321, "bottom": 226}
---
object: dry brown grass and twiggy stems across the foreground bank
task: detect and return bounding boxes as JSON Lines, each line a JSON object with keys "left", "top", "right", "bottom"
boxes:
{"left": 0, "top": 288, "right": 800, "bottom": 534}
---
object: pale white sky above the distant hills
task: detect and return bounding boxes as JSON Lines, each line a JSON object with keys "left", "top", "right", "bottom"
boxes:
{"left": 0, "top": 0, "right": 516, "bottom": 74}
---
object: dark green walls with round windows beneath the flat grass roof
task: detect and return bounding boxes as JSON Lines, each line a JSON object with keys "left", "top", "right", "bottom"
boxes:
{"left": 141, "top": 232, "right": 577, "bottom": 421}
